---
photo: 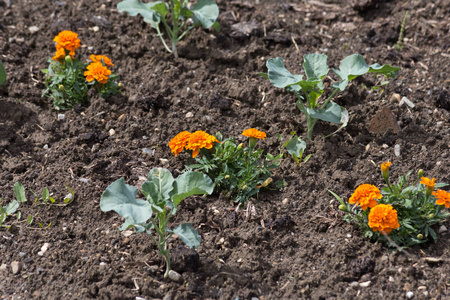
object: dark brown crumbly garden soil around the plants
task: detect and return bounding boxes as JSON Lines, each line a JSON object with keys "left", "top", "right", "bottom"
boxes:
{"left": 0, "top": 0, "right": 450, "bottom": 300}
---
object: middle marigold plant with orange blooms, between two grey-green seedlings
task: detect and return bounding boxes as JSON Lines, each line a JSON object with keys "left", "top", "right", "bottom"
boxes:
{"left": 169, "top": 129, "right": 283, "bottom": 203}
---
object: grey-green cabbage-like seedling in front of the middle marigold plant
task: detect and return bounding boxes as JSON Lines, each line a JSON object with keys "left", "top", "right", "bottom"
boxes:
{"left": 100, "top": 168, "right": 214, "bottom": 278}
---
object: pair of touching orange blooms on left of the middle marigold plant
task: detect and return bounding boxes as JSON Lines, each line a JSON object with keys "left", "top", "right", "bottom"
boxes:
{"left": 169, "top": 130, "right": 219, "bottom": 157}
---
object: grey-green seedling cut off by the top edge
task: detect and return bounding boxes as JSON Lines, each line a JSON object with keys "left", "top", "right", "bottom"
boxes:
{"left": 117, "top": 0, "right": 220, "bottom": 57}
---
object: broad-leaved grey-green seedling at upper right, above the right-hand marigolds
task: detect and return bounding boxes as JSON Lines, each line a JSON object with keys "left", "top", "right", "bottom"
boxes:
{"left": 260, "top": 53, "right": 399, "bottom": 140}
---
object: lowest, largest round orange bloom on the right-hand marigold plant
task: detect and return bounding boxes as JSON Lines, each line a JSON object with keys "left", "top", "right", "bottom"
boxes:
{"left": 369, "top": 204, "right": 400, "bottom": 234}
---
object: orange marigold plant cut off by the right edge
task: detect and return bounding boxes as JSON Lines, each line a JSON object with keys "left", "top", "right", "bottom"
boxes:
{"left": 330, "top": 162, "right": 450, "bottom": 249}
